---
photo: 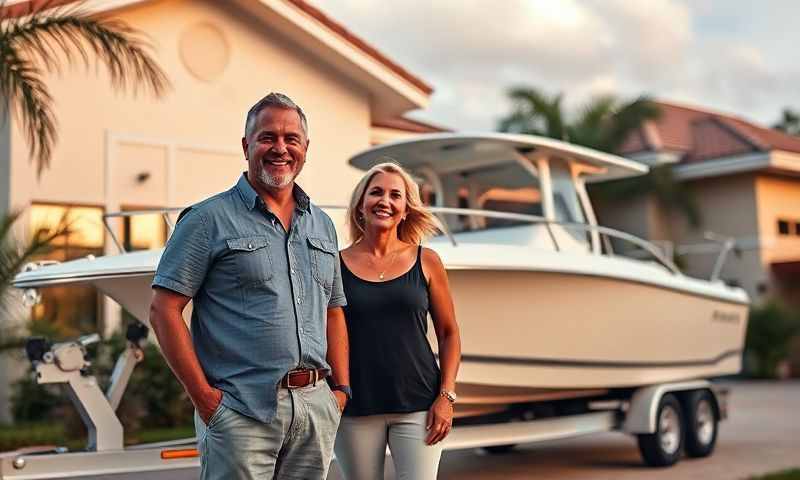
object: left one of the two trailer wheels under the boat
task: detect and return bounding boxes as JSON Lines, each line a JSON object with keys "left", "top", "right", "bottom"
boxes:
{"left": 637, "top": 393, "right": 684, "bottom": 467}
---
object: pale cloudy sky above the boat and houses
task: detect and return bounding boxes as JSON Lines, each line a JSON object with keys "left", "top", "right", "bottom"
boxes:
{"left": 313, "top": 0, "right": 800, "bottom": 130}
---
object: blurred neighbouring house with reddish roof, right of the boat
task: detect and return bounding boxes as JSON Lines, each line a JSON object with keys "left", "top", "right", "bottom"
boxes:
{"left": 597, "top": 101, "right": 800, "bottom": 302}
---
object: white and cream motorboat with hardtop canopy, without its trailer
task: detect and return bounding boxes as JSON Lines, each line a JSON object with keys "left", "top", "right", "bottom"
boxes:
{"left": 13, "top": 133, "right": 749, "bottom": 414}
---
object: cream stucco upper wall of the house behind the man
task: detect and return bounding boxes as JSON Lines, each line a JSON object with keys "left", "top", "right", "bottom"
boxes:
{"left": 11, "top": 0, "right": 371, "bottom": 230}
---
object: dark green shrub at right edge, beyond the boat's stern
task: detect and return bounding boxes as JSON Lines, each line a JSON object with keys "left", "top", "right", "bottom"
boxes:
{"left": 745, "top": 301, "right": 800, "bottom": 378}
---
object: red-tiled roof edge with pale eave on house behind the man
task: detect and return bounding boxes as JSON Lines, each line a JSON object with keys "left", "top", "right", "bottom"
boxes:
{"left": 0, "top": 0, "right": 433, "bottom": 119}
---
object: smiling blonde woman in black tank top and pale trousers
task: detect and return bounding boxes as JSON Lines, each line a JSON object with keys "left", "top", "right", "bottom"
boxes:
{"left": 335, "top": 163, "right": 461, "bottom": 480}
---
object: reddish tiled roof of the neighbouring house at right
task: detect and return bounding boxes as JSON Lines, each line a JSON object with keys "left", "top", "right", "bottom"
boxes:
{"left": 619, "top": 101, "right": 800, "bottom": 163}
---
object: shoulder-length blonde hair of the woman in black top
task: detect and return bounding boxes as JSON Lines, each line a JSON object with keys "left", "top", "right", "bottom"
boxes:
{"left": 347, "top": 157, "right": 442, "bottom": 245}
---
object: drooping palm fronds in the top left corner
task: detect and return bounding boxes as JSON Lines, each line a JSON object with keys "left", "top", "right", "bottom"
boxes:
{"left": 0, "top": 0, "right": 169, "bottom": 175}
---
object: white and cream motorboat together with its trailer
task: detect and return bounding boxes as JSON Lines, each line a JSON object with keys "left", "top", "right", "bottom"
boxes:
{"left": 0, "top": 133, "right": 749, "bottom": 478}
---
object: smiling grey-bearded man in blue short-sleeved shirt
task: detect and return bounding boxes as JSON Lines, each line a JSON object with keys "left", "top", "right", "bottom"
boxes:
{"left": 150, "top": 93, "right": 349, "bottom": 480}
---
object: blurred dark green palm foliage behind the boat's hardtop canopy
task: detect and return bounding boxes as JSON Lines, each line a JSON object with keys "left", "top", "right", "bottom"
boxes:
{"left": 498, "top": 87, "right": 700, "bottom": 227}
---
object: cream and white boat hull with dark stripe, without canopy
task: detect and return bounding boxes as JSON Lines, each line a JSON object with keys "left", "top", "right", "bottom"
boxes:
{"left": 15, "top": 242, "right": 748, "bottom": 405}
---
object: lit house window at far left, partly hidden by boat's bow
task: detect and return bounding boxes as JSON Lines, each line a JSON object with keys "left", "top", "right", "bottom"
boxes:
{"left": 30, "top": 204, "right": 104, "bottom": 339}
